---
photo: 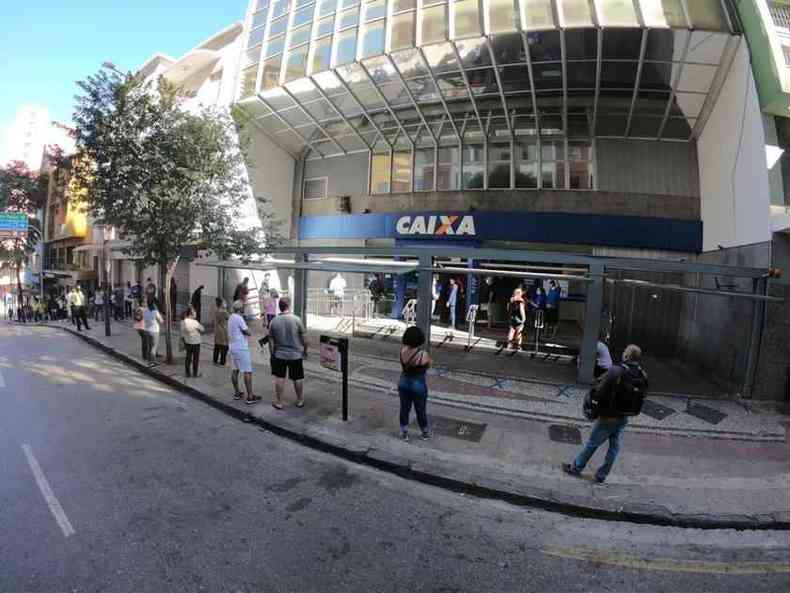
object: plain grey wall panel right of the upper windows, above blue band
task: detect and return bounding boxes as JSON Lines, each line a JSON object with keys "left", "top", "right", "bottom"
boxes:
{"left": 596, "top": 139, "right": 699, "bottom": 197}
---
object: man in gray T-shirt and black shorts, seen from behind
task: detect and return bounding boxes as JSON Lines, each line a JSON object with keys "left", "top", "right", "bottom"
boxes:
{"left": 269, "top": 298, "right": 307, "bottom": 410}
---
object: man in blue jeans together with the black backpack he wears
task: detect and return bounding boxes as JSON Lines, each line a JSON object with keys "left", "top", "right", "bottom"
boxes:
{"left": 562, "top": 344, "right": 647, "bottom": 484}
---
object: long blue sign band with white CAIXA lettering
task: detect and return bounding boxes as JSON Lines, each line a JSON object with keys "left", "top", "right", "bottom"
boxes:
{"left": 299, "top": 212, "right": 702, "bottom": 252}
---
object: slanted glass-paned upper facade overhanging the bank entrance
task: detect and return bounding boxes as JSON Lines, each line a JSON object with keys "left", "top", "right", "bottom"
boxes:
{"left": 239, "top": 0, "right": 736, "bottom": 160}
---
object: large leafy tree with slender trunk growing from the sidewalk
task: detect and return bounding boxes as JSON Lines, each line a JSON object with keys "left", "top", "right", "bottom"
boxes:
{"left": 74, "top": 64, "right": 282, "bottom": 364}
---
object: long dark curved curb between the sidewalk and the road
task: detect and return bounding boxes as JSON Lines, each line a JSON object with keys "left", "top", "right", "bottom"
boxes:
{"left": 39, "top": 324, "right": 790, "bottom": 531}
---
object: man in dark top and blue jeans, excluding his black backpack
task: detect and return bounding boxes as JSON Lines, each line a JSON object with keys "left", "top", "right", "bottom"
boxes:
{"left": 562, "top": 344, "right": 647, "bottom": 484}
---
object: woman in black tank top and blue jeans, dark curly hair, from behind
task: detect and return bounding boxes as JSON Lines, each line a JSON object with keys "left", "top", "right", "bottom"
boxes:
{"left": 398, "top": 326, "right": 432, "bottom": 441}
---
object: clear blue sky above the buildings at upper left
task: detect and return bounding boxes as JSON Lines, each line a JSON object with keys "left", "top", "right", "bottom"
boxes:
{"left": 0, "top": 0, "right": 247, "bottom": 137}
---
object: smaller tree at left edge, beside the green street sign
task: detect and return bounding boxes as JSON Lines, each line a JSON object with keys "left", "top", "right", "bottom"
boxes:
{"left": 0, "top": 161, "right": 49, "bottom": 302}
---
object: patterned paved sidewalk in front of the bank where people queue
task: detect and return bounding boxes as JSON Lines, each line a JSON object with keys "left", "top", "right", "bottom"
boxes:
{"left": 38, "top": 316, "right": 790, "bottom": 529}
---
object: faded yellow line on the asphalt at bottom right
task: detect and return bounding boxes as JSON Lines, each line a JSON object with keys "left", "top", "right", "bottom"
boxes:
{"left": 541, "top": 546, "right": 790, "bottom": 575}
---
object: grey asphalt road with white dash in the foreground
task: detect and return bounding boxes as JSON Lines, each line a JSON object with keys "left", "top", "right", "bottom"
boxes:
{"left": 0, "top": 322, "right": 790, "bottom": 593}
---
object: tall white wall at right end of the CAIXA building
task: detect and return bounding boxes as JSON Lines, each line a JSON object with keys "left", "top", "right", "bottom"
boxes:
{"left": 697, "top": 44, "right": 771, "bottom": 251}
